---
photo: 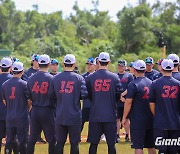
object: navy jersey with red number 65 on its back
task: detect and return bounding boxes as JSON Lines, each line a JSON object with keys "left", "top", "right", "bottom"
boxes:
{"left": 86, "top": 69, "right": 122, "bottom": 122}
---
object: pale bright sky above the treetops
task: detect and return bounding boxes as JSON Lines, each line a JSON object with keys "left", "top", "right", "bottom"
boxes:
{"left": 13, "top": 0, "right": 175, "bottom": 19}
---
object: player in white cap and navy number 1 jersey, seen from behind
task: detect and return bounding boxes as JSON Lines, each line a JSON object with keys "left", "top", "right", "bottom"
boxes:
{"left": 2, "top": 62, "right": 29, "bottom": 154}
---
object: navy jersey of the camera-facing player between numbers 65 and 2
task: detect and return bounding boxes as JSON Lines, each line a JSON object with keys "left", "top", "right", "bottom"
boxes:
{"left": 117, "top": 72, "right": 134, "bottom": 107}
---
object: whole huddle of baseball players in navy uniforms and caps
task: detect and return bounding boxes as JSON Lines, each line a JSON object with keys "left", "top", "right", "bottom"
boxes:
{"left": 1, "top": 52, "right": 180, "bottom": 154}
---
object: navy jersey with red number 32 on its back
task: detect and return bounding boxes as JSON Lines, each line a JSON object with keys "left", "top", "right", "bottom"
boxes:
{"left": 150, "top": 76, "right": 180, "bottom": 130}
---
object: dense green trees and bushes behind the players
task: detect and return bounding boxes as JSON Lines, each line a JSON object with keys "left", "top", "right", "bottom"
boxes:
{"left": 0, "top": 0, "right": 180, "bottom": 71}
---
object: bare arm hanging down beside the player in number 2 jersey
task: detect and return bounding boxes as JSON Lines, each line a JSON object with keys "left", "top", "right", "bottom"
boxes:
{"left": 122, "top": 98, "right": 133, "bottom": 125}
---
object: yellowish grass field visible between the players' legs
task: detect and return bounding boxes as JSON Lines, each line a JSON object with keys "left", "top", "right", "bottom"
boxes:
{"left": 2, "top": 123, "right": 150, "bottom": 154}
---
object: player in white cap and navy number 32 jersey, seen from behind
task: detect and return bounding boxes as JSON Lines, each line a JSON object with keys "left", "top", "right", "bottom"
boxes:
{"left": 150, "top": 59, "right": 180, "bottom": 154}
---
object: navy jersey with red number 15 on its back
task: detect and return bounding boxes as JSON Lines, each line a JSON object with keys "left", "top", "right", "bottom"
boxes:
{"left": 49, "top": 71, "right": 88, "bottom": 125}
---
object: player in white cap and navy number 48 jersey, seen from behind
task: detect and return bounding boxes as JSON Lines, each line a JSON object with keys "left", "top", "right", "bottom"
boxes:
{"left": 27, "top": 55, "right": 56, "bottom": 154}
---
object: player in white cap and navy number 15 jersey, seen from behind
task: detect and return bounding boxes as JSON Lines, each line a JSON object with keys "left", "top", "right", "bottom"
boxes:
{"left": 49, "top": 54, "right": 88, "bottom": 154}
